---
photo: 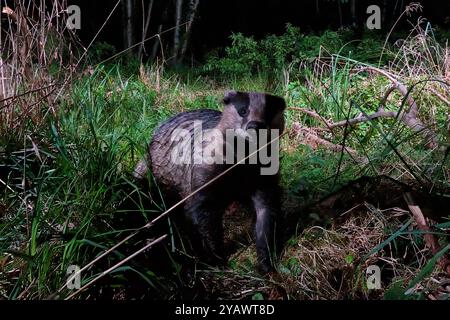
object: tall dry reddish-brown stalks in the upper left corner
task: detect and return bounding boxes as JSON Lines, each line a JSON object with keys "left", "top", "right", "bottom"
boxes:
{"left": 0, "top": 0, "right": 77, "bottom": 136}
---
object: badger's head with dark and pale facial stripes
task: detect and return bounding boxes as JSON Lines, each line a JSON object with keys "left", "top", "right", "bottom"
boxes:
{"left": 221, "top": 91, "right": 286, "bottom": 134}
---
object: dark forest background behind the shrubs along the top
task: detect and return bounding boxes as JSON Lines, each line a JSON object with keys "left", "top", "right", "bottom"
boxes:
{"left": 69, "top": 0, "right": 450, "bottom": 60}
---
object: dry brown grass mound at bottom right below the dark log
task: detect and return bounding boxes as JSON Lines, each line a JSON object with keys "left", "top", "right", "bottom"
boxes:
{"left": 200, "top": 203, "right": 449, "bottom": 300}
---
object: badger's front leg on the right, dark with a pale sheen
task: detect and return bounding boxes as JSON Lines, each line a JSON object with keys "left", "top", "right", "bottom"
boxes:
{"left": 252, "top": 189, "right": 280, "bottom": 274}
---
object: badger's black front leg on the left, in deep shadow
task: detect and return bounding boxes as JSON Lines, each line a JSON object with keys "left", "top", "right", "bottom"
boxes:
{"left": 185, "top": 195, "right": 224, "bottom": 264}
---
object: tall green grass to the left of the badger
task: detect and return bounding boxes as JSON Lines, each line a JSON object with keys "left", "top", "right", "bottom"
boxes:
{"left": 0, "top": 64, "right": 243, "bottom": 299}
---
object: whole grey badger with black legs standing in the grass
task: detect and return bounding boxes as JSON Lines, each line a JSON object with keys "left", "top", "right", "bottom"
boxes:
{"left": 134, "top": 91, "right": 286, "bottom": 273}
